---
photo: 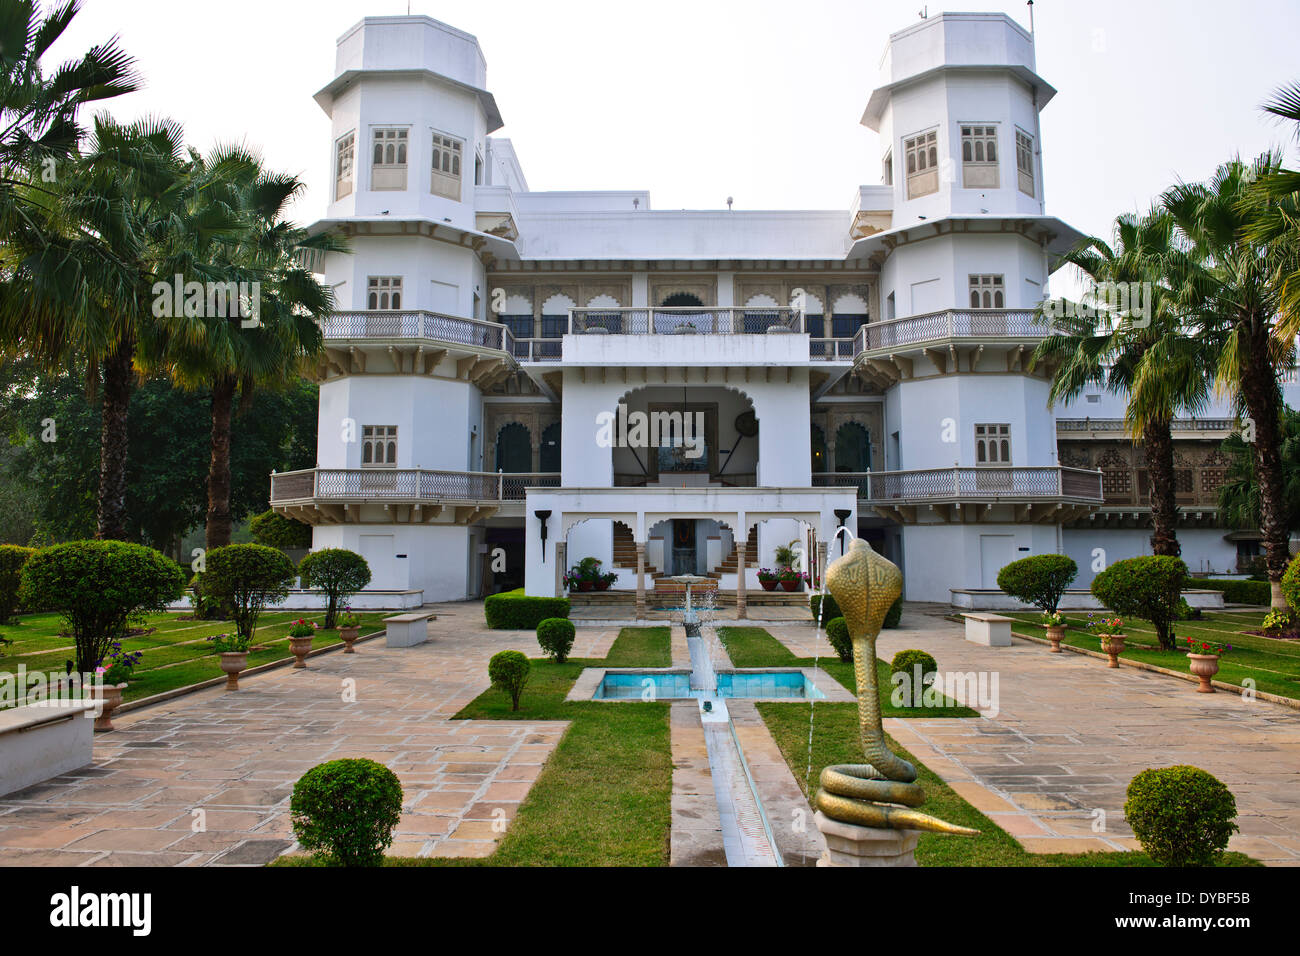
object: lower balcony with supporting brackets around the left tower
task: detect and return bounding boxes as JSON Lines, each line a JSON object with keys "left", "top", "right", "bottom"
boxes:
{"left": 270, "top": 468, "right": 560, "bottom": 524}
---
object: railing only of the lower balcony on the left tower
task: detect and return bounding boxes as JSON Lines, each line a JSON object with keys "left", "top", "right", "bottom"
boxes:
{"left": 270, "top": 468, "right": 560, "bottom": 505}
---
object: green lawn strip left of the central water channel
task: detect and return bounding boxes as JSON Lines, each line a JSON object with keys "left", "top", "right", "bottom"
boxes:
{"left": 273, "top": 627, "right": 672, "bottom": 866}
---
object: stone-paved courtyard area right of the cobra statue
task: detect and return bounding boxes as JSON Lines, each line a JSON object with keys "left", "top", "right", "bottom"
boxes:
{"left": 770, "top": 606, "right": 1300, "bottom": 865}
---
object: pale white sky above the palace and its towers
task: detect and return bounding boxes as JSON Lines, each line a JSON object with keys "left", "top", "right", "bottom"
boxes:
{"left": 45, "top": 0, "right": 1300, "bottom": 247}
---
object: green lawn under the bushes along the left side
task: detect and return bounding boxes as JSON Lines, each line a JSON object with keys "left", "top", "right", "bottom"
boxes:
{"left": 0, "top": 611, "right": 387, "bottom": 701}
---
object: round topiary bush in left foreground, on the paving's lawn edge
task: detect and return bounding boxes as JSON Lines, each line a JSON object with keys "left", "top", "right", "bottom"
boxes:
{"left": 289, "top": 758, "right": 402, "bottom": 866}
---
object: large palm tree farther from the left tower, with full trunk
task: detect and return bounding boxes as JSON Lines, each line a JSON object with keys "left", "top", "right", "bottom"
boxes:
{"left": 0, "top": 117, "right": 241, "bottom": 538}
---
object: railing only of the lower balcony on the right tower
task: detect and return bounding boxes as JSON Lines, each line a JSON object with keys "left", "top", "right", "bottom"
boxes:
{"left": 813, "top": 466, "right": 1102, "bottom": 505}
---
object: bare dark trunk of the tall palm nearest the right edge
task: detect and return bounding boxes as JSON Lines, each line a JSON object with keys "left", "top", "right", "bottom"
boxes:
{"left": 1242, "top": 328, "right": 1291, "bottom": 610}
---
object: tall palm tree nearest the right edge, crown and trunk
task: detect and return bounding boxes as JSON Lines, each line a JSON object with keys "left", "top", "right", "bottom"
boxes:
{"left": 1162, "top": 152, "right": 1296, "bottom": 607}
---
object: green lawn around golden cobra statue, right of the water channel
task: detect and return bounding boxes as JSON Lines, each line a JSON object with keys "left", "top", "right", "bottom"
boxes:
{"left": 758, "top": 701, "right": 1260, "bottom": 866}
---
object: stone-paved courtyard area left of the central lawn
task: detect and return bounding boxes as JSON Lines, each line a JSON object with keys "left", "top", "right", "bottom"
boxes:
{"left": 0, "top": 602, "right": 598, "bottom": 866}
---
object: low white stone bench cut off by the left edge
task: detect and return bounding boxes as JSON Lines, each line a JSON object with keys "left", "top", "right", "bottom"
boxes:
{"left": 0, "top": 700, "right": 98, "bottom": 796}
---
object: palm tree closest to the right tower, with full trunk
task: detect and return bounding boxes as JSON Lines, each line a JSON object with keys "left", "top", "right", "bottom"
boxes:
{"left": 1030, "top": 209, "right": 1206, "bottom": 557}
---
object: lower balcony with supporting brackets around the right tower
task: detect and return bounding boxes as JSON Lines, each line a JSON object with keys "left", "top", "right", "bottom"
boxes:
{"left": 813, "top": 466, "right": 1104, "bottom": 524}
